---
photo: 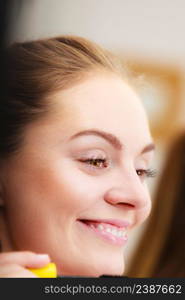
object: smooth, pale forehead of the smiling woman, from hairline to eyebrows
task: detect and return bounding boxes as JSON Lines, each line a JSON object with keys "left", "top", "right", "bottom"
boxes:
{"left": 49, "top": 74, "right": 152, "bottom": 136}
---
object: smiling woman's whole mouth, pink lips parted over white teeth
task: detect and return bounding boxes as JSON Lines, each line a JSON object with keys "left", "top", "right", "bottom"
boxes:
{"left": 81, "top": 220, "right": 129, "bottom": 246}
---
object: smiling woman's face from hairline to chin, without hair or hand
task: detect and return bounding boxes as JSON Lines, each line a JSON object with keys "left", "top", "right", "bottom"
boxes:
{"left": 4, "top": 74, "right": 153, "bottom": 276}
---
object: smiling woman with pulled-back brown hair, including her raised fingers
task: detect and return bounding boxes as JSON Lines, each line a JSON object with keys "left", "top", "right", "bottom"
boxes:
{"left": 0, "top": 36, "right": 154, "bottom": 277}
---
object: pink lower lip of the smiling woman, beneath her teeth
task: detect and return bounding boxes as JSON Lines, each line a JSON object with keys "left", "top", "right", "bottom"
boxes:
{"left": 78, "top": 220, "right": 128, "bottom": 246}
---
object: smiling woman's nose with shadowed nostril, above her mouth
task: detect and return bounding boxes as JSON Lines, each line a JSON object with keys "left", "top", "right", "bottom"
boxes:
{"left": 104, "top": 174, "right": 150, "bottom": 209}
